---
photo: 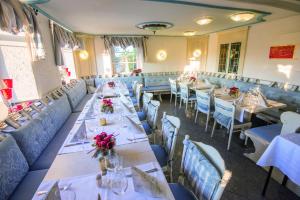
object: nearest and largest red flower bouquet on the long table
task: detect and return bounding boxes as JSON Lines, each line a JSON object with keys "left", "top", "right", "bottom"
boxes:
{"left": 92, "top": 132, "right": 116, "bottom": 158}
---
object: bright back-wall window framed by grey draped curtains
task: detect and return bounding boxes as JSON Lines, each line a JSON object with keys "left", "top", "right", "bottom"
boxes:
{"left": 112, "top": 46, "right": 137, "bottom": 74}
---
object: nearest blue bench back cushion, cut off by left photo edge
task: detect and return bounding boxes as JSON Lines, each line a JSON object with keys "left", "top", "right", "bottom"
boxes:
{"left": 0, "top": 135, "right": 29, "bottom": 200}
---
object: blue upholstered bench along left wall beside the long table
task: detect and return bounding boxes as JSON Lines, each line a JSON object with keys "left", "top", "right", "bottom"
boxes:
{"left": 0, "top": 90, "right": 86, "bottom": 200}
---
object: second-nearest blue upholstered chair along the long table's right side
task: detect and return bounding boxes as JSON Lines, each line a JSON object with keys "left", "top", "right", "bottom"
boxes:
{"left": 151, "top": 112, "right": 180, "bottom": 181}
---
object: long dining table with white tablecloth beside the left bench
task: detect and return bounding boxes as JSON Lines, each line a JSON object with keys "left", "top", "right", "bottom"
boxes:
{"left": 34, "top": 82, "right": 174, "bottom": 200}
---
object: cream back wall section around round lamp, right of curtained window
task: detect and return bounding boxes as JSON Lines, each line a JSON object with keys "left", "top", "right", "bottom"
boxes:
{"left": 143, "top": 36, "right": 187, "bottom": 72}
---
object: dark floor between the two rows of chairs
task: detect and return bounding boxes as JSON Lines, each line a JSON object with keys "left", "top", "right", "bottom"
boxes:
{"left": 158, "top": 96, "right": 300, "bottom": 200}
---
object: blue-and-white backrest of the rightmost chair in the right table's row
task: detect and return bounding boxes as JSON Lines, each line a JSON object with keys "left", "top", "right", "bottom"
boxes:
{"left": 214, "top": 98, "right": 235, "bottom": 129}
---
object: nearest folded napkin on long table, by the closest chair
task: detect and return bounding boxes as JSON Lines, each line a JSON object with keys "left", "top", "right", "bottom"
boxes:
{"left": 131, "top": 167, "right": 164, "bottom": 198}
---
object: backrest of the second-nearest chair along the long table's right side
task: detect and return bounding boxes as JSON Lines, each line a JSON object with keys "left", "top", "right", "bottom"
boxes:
{"left": 161, "top": 112, "right": 180, "bottom": 163}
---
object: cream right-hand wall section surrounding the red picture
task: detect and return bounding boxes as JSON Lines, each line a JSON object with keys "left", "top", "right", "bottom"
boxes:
{"left": 243, "top": 15, "right": 300, "bottom": 85}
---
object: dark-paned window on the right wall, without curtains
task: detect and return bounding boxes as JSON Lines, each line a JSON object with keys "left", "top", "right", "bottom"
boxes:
{"left": 218, "top": 42, "right": 241, "bottom": 74}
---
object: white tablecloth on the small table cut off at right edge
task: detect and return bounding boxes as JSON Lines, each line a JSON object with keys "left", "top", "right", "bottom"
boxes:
{"left": 257, "top": 133, "right": 300, "bottom": 185}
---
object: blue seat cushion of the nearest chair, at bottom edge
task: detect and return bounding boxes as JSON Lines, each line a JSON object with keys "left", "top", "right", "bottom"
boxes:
{"left": 169, "top": 183, "right": 197, "bottom": 200}
